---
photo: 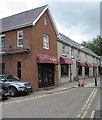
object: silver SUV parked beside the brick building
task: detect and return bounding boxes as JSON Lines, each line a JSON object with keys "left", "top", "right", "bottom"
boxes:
{"left": 0, "top": 75, "right": 32, "bottom": 97}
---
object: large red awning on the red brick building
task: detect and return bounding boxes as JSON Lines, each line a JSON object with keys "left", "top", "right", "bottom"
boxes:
{"left": 37, "top": 54, "right": 59, "bottom": 64}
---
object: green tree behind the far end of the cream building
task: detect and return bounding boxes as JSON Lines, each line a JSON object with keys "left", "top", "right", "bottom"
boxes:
{"left": 81, "top": 36, "right": 102, "bottom": 56}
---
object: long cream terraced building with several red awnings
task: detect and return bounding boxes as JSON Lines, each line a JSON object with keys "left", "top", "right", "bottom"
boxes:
{"left": 58, "top": 33, "right": 101, "bottom": 84}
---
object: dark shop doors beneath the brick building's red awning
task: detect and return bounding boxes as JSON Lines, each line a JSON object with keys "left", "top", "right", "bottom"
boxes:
{"left": 38, "top": 64, "right": 55, "bottom": 88}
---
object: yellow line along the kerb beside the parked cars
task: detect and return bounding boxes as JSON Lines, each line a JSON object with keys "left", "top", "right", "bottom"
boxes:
{"left": 3, "top": 88, "right": 77, "bottom": 105}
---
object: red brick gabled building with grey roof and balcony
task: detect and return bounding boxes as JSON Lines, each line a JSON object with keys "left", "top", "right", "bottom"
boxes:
{"left": 0, "top": 6, "right": 59, "bottom": 90}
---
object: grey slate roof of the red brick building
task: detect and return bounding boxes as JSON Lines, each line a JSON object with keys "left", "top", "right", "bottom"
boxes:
{"left": 0, "top": 5, "right": 47, "bottom": 32}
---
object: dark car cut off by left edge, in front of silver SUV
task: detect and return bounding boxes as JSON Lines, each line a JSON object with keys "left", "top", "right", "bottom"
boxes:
{"left": 0, "top": 82, "right": 10, "bottom": 100}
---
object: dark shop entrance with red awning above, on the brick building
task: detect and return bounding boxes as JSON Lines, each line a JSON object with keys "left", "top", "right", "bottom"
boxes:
{"left": 37, "top": 54, "right": 59, "bottom": 88}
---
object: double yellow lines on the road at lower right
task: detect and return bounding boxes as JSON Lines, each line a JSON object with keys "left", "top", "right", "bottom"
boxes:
{"left": 77, "top": 88, "right": 98, "bottom": 119}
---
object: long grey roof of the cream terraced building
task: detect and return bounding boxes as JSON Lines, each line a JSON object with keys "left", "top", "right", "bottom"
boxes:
{"left": 59, "top": 33, "right": 99, "bottom": 58}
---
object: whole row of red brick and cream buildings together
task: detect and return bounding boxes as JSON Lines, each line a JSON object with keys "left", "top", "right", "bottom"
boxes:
{"left": 0, "top": 5, "right": 100, "bottom": 90}
